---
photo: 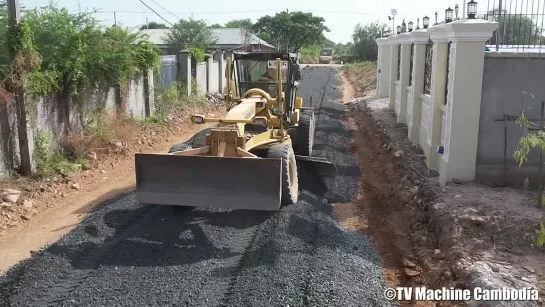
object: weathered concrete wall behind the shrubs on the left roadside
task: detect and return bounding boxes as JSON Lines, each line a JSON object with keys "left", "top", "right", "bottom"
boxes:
{"left": 0, "top": 51, "right": 226, "bottom": 178}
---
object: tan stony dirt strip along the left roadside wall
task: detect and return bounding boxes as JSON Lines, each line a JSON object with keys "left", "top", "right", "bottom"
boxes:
{"left": 0, "top": 96, "right": 225, "bottom": 264}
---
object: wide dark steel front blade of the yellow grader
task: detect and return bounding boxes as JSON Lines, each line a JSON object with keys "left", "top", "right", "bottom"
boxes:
{"left": 135, "top": 154, "right": 282, "bottom": 210}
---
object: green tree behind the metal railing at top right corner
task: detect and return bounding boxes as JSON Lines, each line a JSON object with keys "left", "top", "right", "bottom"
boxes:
{"left": 488, "top": 9, "right": 544, "bottom": 45}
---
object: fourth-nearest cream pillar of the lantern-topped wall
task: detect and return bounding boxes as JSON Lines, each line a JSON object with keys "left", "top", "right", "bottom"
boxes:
{"left": 395, "top": 33, "right": 412, "bottom": 124}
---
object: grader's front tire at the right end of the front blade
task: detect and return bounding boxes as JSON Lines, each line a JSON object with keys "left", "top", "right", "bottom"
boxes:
{"left": 267, "top": 144, "right": 299, "bottom": 206}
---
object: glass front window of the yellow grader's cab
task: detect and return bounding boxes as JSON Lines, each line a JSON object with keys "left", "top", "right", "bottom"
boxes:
{"left": 236, "top": 59, "right": 289, "bottom": 98}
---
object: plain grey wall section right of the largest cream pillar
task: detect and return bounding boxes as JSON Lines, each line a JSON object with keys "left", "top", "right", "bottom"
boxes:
{"left": 477, "top": 51, "right": 545, "bottom": 185}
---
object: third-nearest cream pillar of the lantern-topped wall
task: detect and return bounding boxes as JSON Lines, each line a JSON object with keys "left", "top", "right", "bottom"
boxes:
{"left": 407, "top": 29, "right": 430, "bottom": 144}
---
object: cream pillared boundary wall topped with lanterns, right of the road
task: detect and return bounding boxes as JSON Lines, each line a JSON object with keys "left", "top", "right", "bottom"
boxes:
{"left": 377, "top": 19, "right": 498, "bottom": 185}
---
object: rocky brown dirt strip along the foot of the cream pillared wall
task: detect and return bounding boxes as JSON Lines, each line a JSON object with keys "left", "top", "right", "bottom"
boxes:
{"left": 347, "top": 70, "right": 545, "bottom": 306}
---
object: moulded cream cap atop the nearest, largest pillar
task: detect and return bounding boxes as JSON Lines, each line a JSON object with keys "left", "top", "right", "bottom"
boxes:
{"left": 444, "top": 19, "right": 498, "bottom": 42}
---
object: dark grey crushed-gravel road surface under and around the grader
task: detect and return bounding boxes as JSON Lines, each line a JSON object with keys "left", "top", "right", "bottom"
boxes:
{"left": 0, "top": 66, "right": 390, "bottom": 307}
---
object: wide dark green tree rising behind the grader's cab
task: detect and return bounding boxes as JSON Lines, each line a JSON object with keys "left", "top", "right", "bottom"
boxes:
{"left": 253, "top": 11, "right": 329, "bottom": 52}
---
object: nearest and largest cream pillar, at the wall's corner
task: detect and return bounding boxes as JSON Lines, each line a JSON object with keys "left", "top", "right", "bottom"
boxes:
{"left": 438, "top": 19, "right": 498, "bottom": 185}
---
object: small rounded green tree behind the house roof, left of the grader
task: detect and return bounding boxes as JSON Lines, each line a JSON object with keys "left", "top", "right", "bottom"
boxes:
{"left": 165, "top": 17, "right": 216, "bottom": 50}
